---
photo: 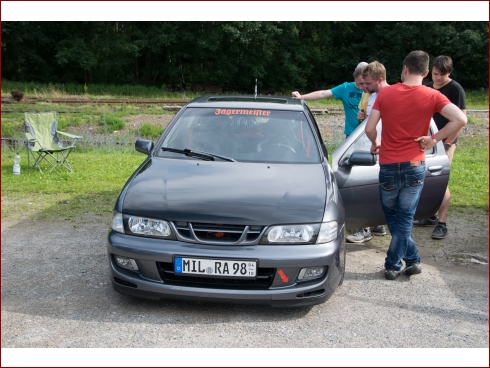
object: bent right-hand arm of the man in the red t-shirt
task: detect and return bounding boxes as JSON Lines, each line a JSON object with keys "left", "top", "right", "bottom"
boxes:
{"left": 415, "top": 103, "right": 468, "bottom": 151}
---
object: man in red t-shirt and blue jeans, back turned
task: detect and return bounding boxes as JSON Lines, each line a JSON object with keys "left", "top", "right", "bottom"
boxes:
{"left": 366, "top": 51, "right": 467, "bottom": 280}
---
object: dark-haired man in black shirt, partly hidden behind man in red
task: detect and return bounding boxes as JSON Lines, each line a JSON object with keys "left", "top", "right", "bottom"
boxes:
{"left": 413, "top": 55, "right": 466, "bottom": 239}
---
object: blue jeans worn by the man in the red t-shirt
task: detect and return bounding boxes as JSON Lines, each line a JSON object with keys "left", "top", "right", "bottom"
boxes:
{"left": 379, "top": 161, "right": 425, "bottom": 271}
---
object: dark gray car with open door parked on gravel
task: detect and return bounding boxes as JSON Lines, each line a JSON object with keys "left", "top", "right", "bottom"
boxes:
{"left": 107, "top": 96, "right": 449, "bottom": 306}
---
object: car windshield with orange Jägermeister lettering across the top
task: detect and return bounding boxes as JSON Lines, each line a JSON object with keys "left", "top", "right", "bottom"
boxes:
{"left": 158, "top": 108, "right": 320, "bottom": 163}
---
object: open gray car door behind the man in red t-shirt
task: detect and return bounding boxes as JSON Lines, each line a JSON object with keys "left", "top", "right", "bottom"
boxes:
{"left": 332, "top": 119, "right": 449, "bottom": 230}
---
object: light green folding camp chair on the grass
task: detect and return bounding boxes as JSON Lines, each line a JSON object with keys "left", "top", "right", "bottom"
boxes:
{"left": 24, "top": 112, "right": 82, "bottom": 172}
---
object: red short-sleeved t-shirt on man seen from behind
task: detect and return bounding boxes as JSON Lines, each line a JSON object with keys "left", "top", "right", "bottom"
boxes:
{"left": 373, "top": 83, "right": 451, "bottom": 164}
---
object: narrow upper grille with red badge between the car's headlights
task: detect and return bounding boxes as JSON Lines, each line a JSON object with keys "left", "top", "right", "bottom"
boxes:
{"left": 173, "top": 222, "right": 264, "bottom": 245}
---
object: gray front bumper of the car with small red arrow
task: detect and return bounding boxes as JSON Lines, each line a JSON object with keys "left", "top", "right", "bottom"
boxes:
{"left": 107, "top": 227, "right": 345, "bottom": 307}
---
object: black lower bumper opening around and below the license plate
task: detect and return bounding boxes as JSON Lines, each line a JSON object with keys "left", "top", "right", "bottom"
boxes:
{"left": 157, "top": 262, "right": 276, "bottom": 290}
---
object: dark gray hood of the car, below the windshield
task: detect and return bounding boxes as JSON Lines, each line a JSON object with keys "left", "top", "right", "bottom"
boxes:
{"left": 120, "top": 158, "right": 326, "bottom": 225}
